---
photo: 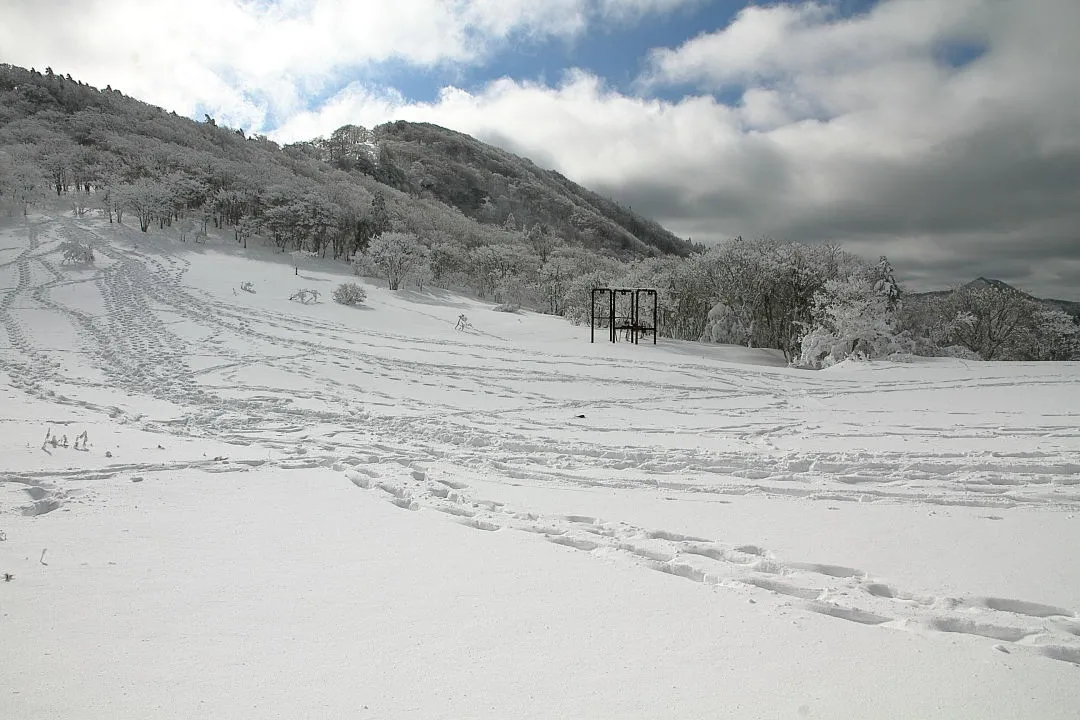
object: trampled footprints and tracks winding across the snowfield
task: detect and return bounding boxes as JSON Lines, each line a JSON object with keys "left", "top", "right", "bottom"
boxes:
{"left": 6, "top": 209, "right": 1080, "bottom": 665}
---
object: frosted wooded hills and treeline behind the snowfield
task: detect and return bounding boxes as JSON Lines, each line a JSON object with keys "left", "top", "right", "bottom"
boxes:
{"left": 0, "top": 66, "right": 1080, "bottom": 367}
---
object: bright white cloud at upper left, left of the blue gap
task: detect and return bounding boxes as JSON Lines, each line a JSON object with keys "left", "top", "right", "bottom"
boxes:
{"left": 0, "top": 0, "right": 700, "bottom": 131}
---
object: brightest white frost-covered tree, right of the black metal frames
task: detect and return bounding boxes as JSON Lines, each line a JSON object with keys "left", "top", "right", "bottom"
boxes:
{"left": 798, "top": 273, "right": 896, "bottom": 368}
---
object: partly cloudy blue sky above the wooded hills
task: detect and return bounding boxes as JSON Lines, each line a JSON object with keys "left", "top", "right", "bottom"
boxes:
{"left": 6, "top": 0, "right": 1080, "bottom": 300}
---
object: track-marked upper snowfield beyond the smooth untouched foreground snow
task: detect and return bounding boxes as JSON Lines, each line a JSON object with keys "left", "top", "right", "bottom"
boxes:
{"left": 0, "top": 207, "right": 1080, "bottom": 707}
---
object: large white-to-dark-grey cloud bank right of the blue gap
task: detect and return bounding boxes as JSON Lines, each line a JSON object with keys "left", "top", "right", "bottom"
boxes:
{"left": 267, "top": 0, "right": 1080, "bottom": 297}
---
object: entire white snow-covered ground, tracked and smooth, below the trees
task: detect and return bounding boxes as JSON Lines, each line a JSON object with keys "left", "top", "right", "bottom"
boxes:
{"left": 0, "top": 212, "right": 1080, "bottom": 719}
